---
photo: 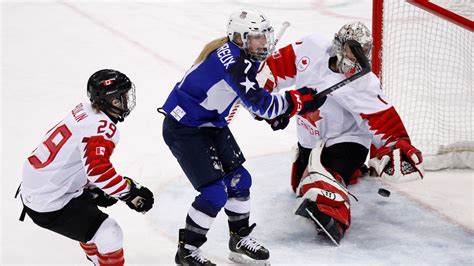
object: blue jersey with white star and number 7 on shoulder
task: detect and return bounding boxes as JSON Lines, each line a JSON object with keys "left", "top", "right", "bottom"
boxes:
{"left": 163, "top": 42, "right": 288, "bottom": 128}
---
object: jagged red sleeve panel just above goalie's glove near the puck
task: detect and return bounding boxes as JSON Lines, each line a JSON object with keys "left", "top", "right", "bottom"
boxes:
{"left": 360, "top": 107, "right": 408, "bottom": 143}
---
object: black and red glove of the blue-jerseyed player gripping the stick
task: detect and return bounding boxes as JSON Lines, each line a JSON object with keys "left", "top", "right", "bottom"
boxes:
{"left": 285, "top": 87, "right": 327, "bottom": 117}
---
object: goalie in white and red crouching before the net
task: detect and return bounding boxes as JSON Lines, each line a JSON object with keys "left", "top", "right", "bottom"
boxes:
{"left": 258, "top": 22, "right": 423, "bottom": 243}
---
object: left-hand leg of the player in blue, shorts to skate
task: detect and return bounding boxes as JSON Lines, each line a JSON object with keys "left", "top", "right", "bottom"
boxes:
{"left": 163, "top": 118, "right": 227, "bottom": 265}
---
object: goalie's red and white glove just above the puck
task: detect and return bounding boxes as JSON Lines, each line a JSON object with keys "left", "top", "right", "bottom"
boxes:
{"left": 369, "top": 138, "right": 424, "bottom": 183}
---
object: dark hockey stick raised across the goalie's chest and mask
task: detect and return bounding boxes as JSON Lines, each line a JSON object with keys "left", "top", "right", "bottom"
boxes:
{"left": 313, "top": 40, "right": 371, "bottom": 99}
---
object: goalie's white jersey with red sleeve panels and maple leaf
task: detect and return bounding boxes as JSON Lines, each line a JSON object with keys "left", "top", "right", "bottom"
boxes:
{"left": 258, "top": 34, "right": 408, "bottom": 148}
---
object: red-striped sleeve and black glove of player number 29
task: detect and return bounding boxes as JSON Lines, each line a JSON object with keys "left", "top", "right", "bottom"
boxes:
{"left": 82, "top": 132, "right": 154, "bottom": 212}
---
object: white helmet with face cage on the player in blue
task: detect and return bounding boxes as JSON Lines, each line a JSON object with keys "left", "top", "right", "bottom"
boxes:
{"left": 227, "top": 8, "right": 274, "bottom": 61}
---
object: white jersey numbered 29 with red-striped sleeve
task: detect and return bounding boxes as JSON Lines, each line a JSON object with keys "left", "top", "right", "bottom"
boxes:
{"left": 21, "top": 103, "right": 130, "bottom": 212}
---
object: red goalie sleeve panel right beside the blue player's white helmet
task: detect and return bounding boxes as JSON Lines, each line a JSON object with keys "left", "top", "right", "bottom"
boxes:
{"left": 267, "top": 44, "right": 296, "bottom": 80}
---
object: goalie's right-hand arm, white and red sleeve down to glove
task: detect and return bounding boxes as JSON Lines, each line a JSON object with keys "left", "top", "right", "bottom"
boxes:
{"left": 336, "top": 82, "right": 424, "bottom": 182}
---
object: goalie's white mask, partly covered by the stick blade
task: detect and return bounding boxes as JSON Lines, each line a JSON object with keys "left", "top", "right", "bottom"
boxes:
{"left": 332, "top": 21, "right": 372, "bottom": 77}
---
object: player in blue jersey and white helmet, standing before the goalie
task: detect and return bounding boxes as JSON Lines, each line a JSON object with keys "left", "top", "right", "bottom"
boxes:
{"left": 162, "top": 9, "right": 325, "bottom": 265}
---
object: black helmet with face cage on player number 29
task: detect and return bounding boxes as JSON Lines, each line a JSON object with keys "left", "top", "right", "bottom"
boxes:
{"left": 87, "top": 69, "right": 135, "bottom": 122}
